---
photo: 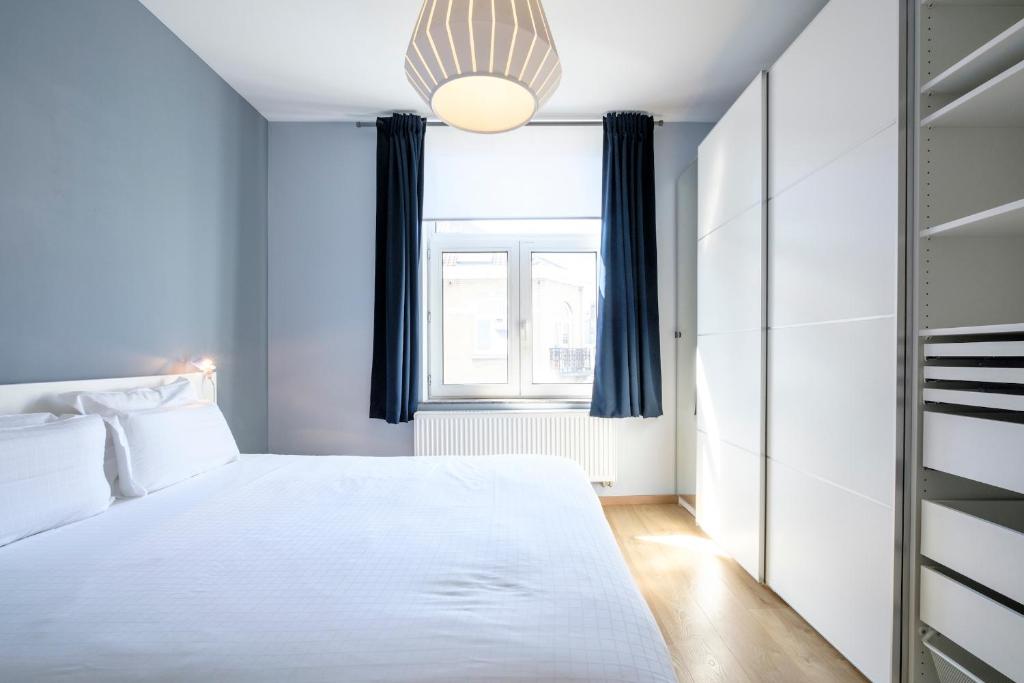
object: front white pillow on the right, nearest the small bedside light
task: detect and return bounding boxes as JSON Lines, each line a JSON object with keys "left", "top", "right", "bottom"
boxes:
{"left": 110, "top": 402, "right": 239, "bottom": 496}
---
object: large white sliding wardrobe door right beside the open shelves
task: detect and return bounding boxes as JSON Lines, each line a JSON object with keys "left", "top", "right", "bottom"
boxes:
{"left": 766, "top": 0, "right": 902, "bottom": 681}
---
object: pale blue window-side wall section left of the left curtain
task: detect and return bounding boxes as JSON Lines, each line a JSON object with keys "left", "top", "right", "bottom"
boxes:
{"left": 268, "top": 123, "right": 413, "bottom": 456}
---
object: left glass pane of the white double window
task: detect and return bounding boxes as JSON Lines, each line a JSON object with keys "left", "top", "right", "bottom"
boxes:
{"left": 441, "top": 252, "right": 509, "bottom": 384}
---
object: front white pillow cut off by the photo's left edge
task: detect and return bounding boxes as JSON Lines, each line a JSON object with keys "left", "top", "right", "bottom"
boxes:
{"left": 0, "top": 416, "right": 111, "bottom": 546}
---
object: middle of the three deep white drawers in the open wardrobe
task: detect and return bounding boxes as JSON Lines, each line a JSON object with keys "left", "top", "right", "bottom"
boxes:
{"left": 921, "top": 501, "right": 1024, "bottom": 603}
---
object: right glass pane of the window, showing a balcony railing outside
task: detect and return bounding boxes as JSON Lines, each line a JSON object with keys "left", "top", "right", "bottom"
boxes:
{"left": 530, "top": 252, "right": 597, "bottom": 384}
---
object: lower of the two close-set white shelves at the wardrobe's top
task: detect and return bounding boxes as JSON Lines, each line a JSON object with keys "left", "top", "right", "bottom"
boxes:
{"left": 921, "top": 61, "right": 1024, "bottom": 128}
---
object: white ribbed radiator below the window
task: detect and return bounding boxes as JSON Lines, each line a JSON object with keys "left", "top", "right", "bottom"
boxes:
{"left": 413, "top": 411, "right": 618, "bottom": 484}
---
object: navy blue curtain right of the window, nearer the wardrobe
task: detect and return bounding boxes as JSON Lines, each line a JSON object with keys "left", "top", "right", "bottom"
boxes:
{"left": 590, "top": 113, "right": 662, "bottom": 418}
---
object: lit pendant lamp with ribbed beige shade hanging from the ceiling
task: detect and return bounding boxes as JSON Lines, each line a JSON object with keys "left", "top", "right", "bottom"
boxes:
{"left": 406, "top": 0, "right": 562, "bottom": 133}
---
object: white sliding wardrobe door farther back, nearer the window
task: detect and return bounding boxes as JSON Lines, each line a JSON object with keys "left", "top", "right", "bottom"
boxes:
{"left": 696, "top": 74, "right": 766, "bottom": 579}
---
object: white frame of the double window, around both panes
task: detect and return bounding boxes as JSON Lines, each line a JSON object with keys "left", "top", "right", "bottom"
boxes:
{"left": 423, "top": 219, "right": 601, "bottom": 401}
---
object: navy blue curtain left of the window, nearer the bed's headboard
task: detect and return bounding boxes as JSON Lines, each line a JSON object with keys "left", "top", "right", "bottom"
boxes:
{"left": 370, "top": 114, "right": 427, "bottom": 424}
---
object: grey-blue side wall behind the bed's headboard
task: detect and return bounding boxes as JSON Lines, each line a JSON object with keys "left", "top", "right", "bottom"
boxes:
{"left": 0, "top": 0, "right": 267, "bottom": 451}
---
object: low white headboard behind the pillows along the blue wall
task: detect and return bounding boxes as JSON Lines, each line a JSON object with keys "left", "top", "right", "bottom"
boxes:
{"left": 0, "top": 373, "right": 217, "bottom": 415}
